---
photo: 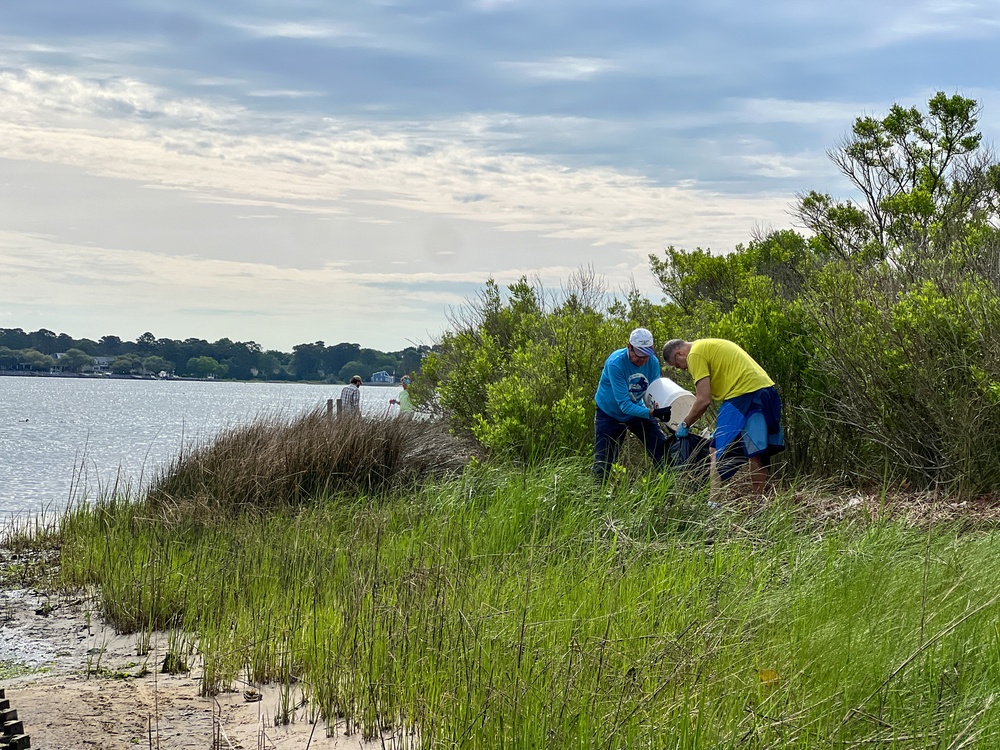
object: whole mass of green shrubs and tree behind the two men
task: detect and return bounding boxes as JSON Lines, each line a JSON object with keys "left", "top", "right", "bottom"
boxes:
{"left": 413, "top": 94, "right": 1000, "bottom": 495}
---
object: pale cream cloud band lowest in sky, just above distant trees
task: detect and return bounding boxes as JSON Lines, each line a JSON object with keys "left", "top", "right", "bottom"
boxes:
{"left": 0, "top": 231, "right": 616, "bottom": 351}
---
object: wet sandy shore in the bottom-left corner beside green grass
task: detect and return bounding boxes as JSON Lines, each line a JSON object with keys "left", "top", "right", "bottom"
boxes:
{"left": 0, "top": 590, "right": 399, "bottom": 750}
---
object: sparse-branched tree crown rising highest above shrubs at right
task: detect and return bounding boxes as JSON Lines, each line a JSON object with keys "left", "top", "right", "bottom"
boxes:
{"left": 796, "top": 92, "right": 1000, "bottom": 264}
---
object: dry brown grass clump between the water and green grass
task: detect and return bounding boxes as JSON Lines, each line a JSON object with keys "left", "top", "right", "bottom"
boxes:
{"left": 148, "top": 410, "right": 470, "bottom": 517}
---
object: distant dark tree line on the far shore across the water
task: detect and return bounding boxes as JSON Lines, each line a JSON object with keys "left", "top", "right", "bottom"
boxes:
{"left": 0, "top": 328, "right": 430, "bottom": 383}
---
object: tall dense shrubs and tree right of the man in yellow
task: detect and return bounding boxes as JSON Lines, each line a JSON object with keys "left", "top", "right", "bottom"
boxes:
{"left": 650, "top": 94, "right": 1000, "bottom": 493}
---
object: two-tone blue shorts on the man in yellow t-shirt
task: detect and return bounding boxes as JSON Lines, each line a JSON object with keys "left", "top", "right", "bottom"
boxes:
{"left": 712, "top": 386, "right": 785, "bottom": 479}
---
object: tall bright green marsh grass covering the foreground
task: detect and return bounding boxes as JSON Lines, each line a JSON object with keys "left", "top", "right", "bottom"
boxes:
{"left": 56, "top": 461, "right": 1000, "bottom": 748}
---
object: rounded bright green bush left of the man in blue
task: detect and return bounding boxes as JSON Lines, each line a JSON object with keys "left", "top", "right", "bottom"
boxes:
{"left": 412, "top": 271, "right": 663, "bottom": 461}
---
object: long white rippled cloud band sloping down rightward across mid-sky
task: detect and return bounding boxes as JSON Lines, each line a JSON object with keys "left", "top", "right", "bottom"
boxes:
{"left": 0, "top": 64, "right": 787, "bottom": 256}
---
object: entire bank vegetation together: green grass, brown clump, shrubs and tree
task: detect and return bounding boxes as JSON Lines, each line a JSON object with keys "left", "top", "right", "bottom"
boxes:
{"left": 11, "top": 95, "right": 1000, "bottom": 750}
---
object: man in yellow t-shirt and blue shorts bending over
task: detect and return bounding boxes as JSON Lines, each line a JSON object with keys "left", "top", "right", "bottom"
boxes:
{"left": 663, "top": 339, "right": 785, "bottom": 492}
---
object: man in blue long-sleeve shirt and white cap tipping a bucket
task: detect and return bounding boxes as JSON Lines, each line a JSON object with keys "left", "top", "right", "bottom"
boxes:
{"left": 594, "top": 328, "right": 667, "bottom": 480}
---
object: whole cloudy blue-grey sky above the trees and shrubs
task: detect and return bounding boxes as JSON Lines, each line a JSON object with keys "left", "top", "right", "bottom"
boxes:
{"left": 0, "top": 0, "right": 1000, "bottom": 351}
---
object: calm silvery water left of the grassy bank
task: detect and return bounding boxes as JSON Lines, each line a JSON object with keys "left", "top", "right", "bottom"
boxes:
{"left": 0, "top": 377, "right": 399, "bottom": 519}
